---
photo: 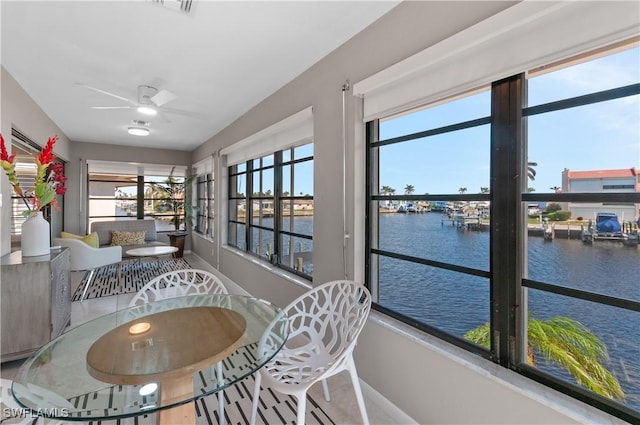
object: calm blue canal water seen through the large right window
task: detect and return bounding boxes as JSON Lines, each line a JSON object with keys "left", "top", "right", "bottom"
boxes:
{"left": 379, "top": 213, "right": 640, "bottom": 410}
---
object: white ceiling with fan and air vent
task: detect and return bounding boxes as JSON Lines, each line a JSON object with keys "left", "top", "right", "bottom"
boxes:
{"left": 0, "top": 0, "right": 398, "bottom": 150}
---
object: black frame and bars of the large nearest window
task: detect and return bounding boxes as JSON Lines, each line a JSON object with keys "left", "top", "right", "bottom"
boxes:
{"left": 365, "top": 64, "right": 640, "bottom": 422}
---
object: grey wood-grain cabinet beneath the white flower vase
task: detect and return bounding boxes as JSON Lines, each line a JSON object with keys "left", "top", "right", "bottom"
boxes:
{"left": 0, "top": 248, "right": 71, "bottom": 362}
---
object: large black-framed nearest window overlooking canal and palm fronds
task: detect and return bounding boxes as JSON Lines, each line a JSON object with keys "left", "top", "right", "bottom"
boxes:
{"left": 367, "top": 45, "right": 640, "bottom": 421}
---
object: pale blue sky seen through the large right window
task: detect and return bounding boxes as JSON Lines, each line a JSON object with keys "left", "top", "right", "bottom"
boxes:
{"left": 380, "top": 47, "right": 640, "bottom": 194}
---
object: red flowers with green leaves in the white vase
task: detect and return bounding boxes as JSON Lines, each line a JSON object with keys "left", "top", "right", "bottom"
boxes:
{"left": 0, "top": 134, "right": 67, "bottom": 217}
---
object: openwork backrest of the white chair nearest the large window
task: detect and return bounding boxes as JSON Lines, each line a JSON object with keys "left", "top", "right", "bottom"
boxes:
{"left": 284, "top": 280, "right": 371, "bottom": 359}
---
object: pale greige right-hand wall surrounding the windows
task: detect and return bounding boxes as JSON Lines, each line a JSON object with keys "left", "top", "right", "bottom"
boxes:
{"left": 193, "top": 1, "right": 632, "bottom": 424}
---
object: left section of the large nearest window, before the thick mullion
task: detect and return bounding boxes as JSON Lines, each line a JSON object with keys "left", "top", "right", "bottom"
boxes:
{"left": 369, "top": 89, "right": 491, "bottom": 338}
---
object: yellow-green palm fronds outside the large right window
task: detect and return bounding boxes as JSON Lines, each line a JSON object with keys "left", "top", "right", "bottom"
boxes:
{"left": 464, "top": 316, "right": 624, "bottom": 400}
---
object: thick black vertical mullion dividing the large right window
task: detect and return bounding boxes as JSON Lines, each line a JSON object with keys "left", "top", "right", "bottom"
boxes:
{"left": 490, "top": 74, "right": 526, "bottom": 367}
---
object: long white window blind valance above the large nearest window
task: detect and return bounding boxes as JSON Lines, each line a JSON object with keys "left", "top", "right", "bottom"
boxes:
{"left": 353, "top": 1, "right": 640, "bottom": 122}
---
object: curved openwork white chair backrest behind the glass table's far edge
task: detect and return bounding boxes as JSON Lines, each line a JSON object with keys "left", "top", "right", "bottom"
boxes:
{"left": 129, "top": 269, "right": 227, "bottom": 307}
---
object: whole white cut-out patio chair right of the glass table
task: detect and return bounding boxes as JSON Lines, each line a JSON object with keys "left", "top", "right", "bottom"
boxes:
{"left": 250, "top": 280, "right": 371, "bottom": 425}
